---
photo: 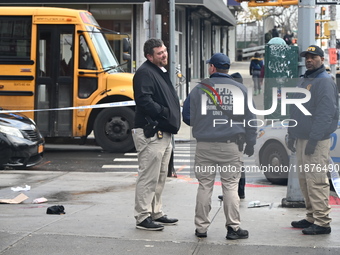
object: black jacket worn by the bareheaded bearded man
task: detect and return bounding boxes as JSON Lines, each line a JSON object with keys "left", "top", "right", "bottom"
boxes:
{"left": 133, "top": 60, "right": 181, "bottom": 134}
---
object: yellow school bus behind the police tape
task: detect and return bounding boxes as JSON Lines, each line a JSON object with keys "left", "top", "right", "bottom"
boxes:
{"left": 0, "top": 7, "right": 134, "bottom": 152}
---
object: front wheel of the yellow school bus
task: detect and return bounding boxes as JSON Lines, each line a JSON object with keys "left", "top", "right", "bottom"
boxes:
{"left": 93, "top": 107, "right": 135, "bottom": 152}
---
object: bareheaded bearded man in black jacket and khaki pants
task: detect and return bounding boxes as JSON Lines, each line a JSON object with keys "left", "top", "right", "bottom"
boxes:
{"left": 132, "top": 39, "right": 181, "bottom": 230}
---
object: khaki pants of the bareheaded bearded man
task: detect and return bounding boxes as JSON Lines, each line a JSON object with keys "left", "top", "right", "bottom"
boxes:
{"left": 132, "top": 128, "right": 172, "bottom": 224}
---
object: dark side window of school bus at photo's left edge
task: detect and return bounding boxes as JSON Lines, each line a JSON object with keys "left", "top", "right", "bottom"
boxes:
{"left": 0, "top": 16, "right": 32, "bottom": 59}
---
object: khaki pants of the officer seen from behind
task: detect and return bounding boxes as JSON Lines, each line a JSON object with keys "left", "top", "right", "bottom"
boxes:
{"left": 194, "top": 142, "right": 243, "bottom": 233}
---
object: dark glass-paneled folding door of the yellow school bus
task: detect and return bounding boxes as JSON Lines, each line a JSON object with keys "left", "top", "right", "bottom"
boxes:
{"left": 35, "top": 25, "right": 75, "bottom": 137}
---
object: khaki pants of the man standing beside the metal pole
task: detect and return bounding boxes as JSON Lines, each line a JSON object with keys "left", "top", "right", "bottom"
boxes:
{"left": 296, "top": 139, "right": 332, "bottom": 227}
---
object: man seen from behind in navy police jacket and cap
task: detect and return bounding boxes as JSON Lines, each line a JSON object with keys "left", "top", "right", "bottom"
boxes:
{"left": 182, "top": 53, "right": 256, "bottom": 240}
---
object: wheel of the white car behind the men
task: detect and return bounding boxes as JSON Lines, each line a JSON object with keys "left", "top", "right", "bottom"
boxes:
{"left": 260, "top": 142, "right": 289, "bottom": 185}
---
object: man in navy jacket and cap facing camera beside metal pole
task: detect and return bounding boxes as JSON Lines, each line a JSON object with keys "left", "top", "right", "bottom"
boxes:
{"left": 288, "top": 45, "right": 339, "bottom": 235}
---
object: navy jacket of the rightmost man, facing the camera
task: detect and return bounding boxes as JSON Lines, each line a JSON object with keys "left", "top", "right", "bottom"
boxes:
{"left": 288, "top": 66, "right": 339, "bottom": 141}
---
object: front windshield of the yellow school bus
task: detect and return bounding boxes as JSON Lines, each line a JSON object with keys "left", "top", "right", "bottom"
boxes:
{"left": 87, "top": 26, "right": 122, "bottom": 72}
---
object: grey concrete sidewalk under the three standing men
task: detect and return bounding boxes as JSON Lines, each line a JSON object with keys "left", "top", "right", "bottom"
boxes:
{"left": 0, "top": 171, "right": 340, "bottom": 255}
